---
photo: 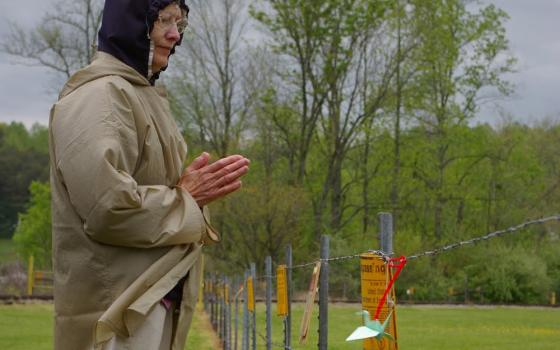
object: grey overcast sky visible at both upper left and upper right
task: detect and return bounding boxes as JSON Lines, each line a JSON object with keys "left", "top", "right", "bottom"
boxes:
{"left": 0, "top": 0, "right": 560, "bottom": 126}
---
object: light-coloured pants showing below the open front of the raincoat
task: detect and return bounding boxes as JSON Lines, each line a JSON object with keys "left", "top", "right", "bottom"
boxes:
{"left": 103, "top": 304, "right": 173, "bottom": 350}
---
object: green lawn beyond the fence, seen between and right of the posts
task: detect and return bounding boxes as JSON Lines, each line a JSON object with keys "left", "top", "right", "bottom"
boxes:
{"left": 250, "top": 304, "right": 560, "bottom": 350}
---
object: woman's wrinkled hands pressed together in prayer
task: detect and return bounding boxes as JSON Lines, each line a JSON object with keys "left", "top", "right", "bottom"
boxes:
{"left": 177, "top": 152, "right": 250, "bottom": 207}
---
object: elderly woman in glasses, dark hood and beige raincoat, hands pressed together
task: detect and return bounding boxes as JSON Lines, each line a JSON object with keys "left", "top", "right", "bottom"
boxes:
{"left": 49, "top": 0, "right": 249, "bottom": 350}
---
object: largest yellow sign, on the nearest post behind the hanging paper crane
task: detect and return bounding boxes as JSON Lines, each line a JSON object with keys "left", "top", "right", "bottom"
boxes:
{"left": 360, "top": 253, "right": 399, "bottom": 350}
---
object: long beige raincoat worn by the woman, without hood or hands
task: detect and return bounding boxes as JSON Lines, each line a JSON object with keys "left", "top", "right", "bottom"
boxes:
{"left": 49, "top": 52, "right": 218, "bottom": 350}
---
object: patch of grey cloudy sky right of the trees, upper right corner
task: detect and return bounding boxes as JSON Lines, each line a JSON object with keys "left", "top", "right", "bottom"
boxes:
{"left": 480, "top": 0, "right": 560, "bottom": 123}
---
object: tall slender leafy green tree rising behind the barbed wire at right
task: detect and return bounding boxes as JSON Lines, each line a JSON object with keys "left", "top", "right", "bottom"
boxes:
{"left": 404, "top": 0, "right": 515, "bottom": 240}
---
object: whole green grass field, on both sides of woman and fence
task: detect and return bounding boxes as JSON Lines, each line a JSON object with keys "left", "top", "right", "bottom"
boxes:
{"left": 0, "top": 304, "right": 560, "bottom": 350}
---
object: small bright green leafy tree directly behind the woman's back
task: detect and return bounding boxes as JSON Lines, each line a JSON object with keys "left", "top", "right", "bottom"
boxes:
{"left": 13, "top": 181, "right": 52, "bottom": 269}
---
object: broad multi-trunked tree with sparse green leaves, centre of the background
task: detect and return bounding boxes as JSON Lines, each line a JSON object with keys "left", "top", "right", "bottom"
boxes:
{"left": 253, "top": 0, "right": 393, "bottom": 236}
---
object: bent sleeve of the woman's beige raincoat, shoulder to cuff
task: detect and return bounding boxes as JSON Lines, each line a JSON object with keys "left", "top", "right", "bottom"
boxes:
{"left": 53, "top": 79, "right": 207, "bottom": 248}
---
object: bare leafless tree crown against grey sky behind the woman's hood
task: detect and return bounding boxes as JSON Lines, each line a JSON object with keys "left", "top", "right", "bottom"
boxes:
{"left": 0, "top": 0, "right": 103, "bottom": 79}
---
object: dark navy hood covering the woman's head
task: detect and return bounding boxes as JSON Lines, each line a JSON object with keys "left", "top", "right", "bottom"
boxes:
{"left": 98, "top": 0, "right": 189, "bottom": 85}
